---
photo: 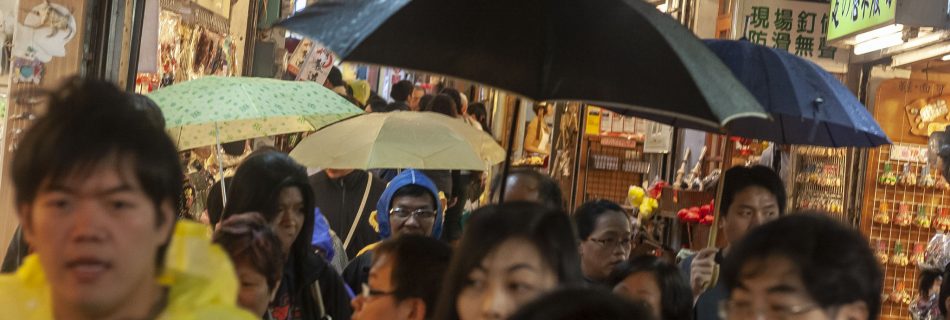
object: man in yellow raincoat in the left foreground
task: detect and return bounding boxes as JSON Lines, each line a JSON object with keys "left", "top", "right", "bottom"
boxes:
{"left": 0, "top": 78, "right": 256, "bottom": 319}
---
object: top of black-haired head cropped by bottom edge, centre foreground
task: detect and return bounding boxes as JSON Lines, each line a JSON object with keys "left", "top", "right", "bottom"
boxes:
{"left": 509, "top": 286, "right": 666, "bottom": 320}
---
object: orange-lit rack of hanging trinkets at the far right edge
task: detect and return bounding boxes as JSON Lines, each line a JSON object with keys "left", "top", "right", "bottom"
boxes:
{"left": 861, "top": 79, "right": 950, "bottom": 319}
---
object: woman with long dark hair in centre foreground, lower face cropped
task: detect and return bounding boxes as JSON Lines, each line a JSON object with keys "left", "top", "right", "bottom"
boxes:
{"left": 435, "top": 202, "right": 583, "bottom": 320}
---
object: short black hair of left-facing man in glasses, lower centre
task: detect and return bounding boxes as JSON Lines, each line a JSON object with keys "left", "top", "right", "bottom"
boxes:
{"left": 373, "top": 235, "right": 452, "bottom": 319}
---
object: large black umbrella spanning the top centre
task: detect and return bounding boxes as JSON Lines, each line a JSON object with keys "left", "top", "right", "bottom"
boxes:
{"left": 278, "top": 0, "right": 766, "bottom": 132}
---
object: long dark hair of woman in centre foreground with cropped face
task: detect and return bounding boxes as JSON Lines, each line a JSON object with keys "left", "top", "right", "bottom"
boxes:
{"left": 435, "top": 202, "right": 583, "bottom": 320}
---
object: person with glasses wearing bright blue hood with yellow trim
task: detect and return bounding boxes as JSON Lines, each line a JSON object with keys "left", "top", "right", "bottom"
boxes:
{"left": 343, "top": 169, "right": 442, "bottom": 294}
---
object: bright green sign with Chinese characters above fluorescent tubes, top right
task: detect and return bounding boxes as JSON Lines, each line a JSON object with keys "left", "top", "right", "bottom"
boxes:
{"left": 828, "top": 0, "right": 897, "bottom": 40}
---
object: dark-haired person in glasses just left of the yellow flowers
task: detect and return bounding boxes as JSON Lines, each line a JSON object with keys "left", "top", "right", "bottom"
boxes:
{"left": 574, "top": 200, "right": 633, "bottom": 284}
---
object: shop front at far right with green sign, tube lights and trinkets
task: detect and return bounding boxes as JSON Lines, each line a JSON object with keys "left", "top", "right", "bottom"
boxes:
{"left": 828, "top": 0, "right": 950, "bottom": 319}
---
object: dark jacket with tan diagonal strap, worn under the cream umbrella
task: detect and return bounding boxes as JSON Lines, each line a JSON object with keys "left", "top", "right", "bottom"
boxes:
{"left": 310, "top": 169, "right": 386, "bottom": 259}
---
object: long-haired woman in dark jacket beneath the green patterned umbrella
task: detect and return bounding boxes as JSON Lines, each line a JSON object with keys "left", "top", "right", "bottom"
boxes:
{"left": 222, "top": 151, "right": 352, "bottom": 320}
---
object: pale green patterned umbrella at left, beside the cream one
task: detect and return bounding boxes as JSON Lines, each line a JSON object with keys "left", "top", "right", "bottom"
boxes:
{"left": 148, "top": 77, "right": 363, "bottom": 150}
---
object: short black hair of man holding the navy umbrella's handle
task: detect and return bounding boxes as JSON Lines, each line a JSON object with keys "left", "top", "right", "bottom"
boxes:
{"left": 719, "top": 166, "right": 788, "bottom": 217}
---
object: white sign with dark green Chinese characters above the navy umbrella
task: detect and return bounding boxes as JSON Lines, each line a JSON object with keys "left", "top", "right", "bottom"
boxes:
{"left": 733, "top": 0, "right": 848, "bottom": 73}
